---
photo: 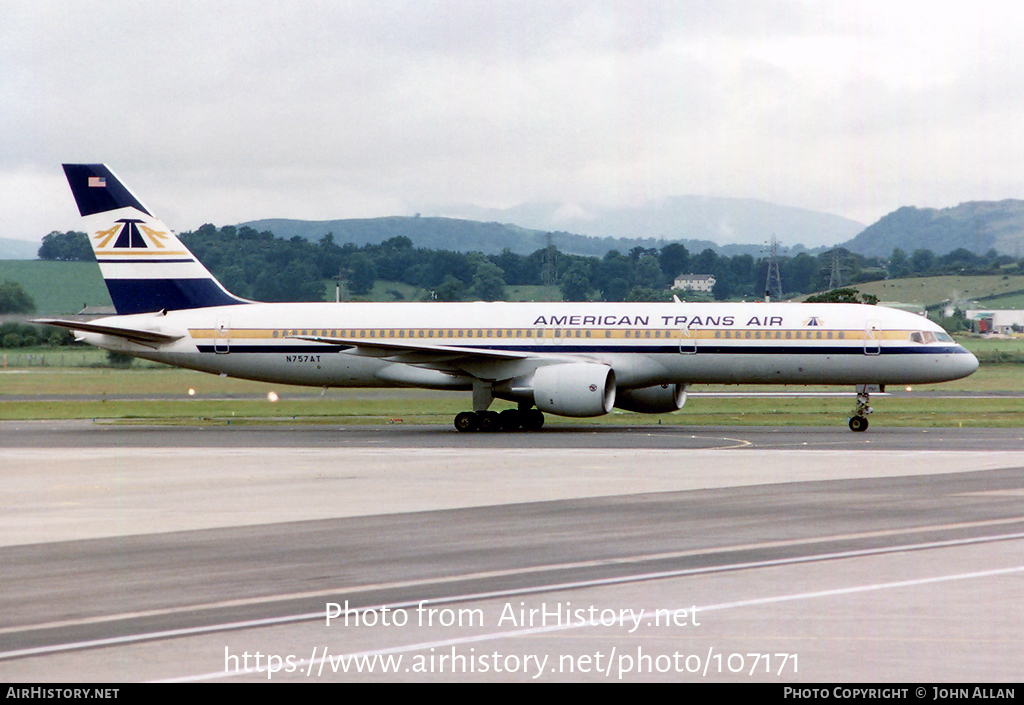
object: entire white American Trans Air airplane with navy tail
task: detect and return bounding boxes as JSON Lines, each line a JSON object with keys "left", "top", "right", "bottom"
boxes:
{"left": 37, "top": 164, "right": 978, "bottom": 431}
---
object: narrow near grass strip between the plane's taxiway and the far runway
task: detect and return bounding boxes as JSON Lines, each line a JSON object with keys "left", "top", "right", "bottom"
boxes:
{"left": 0, "top": 380, "right": 1024, "bottom": 427}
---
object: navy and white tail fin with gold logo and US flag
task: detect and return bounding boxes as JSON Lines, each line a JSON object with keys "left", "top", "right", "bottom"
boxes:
{"left": 63, "top": 164, "right": 249, "bottom": 315}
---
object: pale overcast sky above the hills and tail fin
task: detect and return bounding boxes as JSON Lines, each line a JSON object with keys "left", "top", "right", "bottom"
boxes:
{"left": 0, "top": 0, "right": 1024, "bottom": 240}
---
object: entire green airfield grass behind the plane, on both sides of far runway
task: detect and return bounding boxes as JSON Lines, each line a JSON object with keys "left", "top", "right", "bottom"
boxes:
{"left": 0, "top": 350, "right": 1024, "bottom": 426}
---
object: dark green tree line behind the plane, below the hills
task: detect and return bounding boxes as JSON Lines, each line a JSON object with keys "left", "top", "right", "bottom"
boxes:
{"left": 39, "top": 224, "right": 1024, "bottom": 301}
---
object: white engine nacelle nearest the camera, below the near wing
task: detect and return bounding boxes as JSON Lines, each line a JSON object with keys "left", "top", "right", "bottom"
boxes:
{"left": 530, "top": 363, "right": 615, "bottom": 417}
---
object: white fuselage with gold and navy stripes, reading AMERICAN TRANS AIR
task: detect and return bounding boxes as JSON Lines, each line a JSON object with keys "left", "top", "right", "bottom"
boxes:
{"left": 80, "top": 302, "right": 978, "bottom": 389}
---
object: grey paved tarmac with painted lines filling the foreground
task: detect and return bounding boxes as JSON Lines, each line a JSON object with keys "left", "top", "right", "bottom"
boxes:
{"left": 0, "top": 421, "right": 1024, "bottom": 682}
